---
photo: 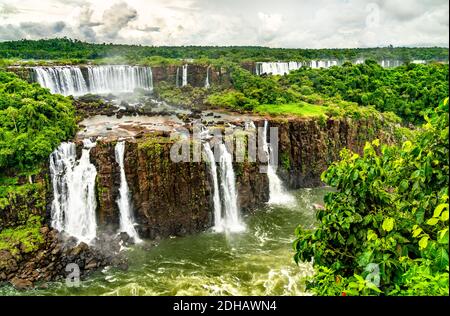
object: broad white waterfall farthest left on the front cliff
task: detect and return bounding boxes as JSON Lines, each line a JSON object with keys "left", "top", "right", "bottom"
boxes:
{"left": 50, "top": 139, "right": 97, "bottom": 243}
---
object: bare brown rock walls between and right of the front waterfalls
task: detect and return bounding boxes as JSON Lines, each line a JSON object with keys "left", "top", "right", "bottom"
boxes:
{"left": 85, "top": 118, "right": 393, "bottom": 239}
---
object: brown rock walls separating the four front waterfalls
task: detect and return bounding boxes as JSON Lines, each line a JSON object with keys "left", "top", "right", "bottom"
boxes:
{"left": 91, "top": 134, "right": 268, "bottom": 239}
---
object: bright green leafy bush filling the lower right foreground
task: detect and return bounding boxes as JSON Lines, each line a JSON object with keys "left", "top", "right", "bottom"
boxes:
{"left": 294, "top": 98, "right": 449, "bottom": 295}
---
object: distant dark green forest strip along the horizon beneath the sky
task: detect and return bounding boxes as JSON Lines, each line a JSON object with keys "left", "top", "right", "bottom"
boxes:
{"left": 0, "top": 38, "right": 448, "bottom": 62}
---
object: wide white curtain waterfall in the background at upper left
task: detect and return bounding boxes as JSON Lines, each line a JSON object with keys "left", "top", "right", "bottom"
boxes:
{"left": 33, "top": 65, "right": 153, "bottom": 96}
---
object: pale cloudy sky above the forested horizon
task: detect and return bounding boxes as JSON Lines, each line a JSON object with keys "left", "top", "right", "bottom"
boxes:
{"left": 0, "top": 0, "right": 449, "bottom": 48}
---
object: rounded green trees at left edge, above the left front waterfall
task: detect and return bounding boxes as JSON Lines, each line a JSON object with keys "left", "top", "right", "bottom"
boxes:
{"left": 0, "top": 72, "right": 76, "bottom": 171}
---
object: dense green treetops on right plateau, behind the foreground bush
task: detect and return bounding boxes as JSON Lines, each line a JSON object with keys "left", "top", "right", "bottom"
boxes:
{"left": 281, "top": 61, "right": 448, "bottom": 123}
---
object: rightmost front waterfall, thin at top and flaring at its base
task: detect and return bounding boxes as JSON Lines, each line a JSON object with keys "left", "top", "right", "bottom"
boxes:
{"left": 263, "top": 120, "right": 295, "bottom": 205}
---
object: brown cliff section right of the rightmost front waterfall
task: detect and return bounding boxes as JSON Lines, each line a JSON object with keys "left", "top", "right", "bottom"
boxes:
{"left": 266, "top": 118, "right": 395, "bottom": 189}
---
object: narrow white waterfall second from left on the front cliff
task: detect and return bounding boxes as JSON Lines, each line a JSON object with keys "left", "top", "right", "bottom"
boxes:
{"left": 115, "top": 141, "right": 141, "bottom": 243}
